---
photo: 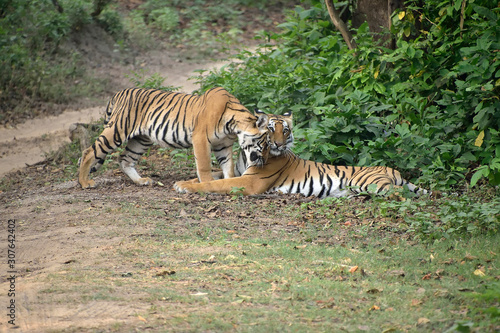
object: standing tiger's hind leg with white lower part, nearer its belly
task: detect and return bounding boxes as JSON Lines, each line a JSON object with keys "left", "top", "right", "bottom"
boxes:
{"left": 120, "top": 135, "right": 153, "bottom": 185}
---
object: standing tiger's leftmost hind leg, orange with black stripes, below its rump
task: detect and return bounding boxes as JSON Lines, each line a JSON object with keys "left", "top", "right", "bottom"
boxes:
{"left": 78, "top": 127, "right": 121, "bottom": 189}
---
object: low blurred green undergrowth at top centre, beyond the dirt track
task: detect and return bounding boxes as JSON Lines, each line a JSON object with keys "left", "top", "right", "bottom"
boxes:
{"left": 126, "top": 0, "right": 292, "bottom": 55}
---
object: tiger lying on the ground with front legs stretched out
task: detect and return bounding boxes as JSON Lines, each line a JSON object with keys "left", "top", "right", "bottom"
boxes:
{"left": 174, "top": 110, "right": 427, "bottom": 198}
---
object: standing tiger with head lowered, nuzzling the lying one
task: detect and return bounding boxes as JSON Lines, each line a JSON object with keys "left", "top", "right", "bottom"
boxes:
{"left": 78, "top": 88, "right": 267, "bottom": 188}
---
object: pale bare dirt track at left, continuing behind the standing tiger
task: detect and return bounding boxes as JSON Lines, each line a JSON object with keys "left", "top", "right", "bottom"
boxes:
{"left": 0, "top": 10, "right": 310, "bottom": 332}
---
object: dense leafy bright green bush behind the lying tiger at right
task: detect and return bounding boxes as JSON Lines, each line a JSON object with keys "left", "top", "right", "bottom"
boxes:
{"left": 195, "top": 0, "right": 500, "bottom": 189}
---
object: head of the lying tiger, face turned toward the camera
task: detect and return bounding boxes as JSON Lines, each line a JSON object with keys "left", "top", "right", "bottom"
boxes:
{"left": 255, "top": 109, "right": 293, "bottom": 156}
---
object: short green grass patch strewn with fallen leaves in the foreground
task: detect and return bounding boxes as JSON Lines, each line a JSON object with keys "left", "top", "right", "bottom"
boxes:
{"left": 60, "top": 230, "right": 499, "bottom": 332}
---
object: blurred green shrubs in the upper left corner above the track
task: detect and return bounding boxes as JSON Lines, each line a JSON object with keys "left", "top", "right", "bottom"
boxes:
{"left": 0, "top": 0, "right": 100, "bottom": 122}
